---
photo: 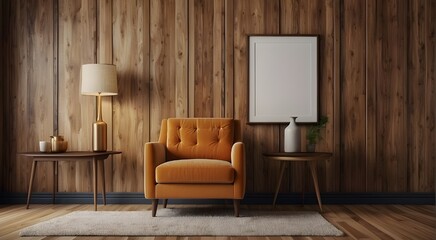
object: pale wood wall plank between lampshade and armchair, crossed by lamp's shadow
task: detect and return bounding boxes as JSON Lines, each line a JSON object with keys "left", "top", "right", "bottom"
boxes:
{"left": 112, "top": 0, "right": 149, "bottom": 192}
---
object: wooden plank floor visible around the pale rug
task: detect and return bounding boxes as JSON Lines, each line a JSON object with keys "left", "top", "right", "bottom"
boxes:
{"left": 0, "top": 204, "right": 436, "bottom": 240}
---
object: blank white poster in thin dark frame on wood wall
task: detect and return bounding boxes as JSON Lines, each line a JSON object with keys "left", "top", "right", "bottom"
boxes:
{"left": 248, "top": 35, "right": 318, "bottom": 123}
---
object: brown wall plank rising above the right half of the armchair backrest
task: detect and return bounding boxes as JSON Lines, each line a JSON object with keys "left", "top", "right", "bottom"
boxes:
{"left": 190, "top": 0, "right": 225, "bottom": 117}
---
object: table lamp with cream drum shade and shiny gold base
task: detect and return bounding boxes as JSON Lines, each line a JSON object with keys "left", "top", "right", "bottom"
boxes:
{"left": 81, "top": 64, "right": 118, "bottom": 152}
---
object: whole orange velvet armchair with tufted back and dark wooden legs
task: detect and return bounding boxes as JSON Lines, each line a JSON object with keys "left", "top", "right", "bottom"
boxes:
{"left": 144, "top": 118, "right": 246, "bottom": 217}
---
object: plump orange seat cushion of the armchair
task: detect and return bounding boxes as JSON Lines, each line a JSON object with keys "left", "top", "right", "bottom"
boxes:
{"left": 156, "top": 159, "right": 235, "bottom": 183}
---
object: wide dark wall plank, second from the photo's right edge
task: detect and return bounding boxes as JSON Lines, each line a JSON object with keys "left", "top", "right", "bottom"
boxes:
{"left": 367, "top": 1, "right": 413, "bottom": 191}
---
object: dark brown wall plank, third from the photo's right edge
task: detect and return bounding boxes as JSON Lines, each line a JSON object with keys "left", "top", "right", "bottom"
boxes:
{"left": 340, "top": 0, "right": 366, "bottom": 192}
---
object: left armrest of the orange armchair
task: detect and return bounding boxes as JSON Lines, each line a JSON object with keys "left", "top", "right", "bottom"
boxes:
{"left": 144, "top": 142, "right": 166, "bottom": 199}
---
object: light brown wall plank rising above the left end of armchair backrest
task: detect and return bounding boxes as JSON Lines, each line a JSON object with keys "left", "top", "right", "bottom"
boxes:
{"left": 149, "top": 0, "right": 176, "bottom": 140}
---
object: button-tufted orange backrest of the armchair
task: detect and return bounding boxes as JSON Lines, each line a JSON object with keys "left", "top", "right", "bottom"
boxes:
{"left": 159, "top": 118, "right": 238, "bottom": 161}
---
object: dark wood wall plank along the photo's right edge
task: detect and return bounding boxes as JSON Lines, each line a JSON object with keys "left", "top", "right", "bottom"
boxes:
{"left": 407, "top": 0, "right": 436, "bottom": 192}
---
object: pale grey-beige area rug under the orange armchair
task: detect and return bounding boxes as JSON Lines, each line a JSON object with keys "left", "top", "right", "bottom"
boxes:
{"left": 20, "top": 208, "right": 343, "bottom": 236}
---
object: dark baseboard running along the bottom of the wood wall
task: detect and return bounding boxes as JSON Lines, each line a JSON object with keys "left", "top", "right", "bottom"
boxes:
{"left": 0, "top": 192, "right": 436, "bottom": 205}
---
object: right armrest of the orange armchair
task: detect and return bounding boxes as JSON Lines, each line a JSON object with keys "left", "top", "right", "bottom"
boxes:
{"left": 231, "top": 142, "right": 246, "bottom": 199}
